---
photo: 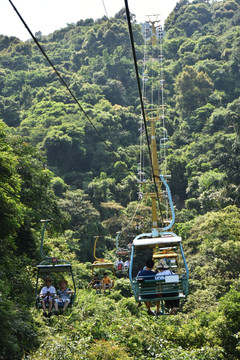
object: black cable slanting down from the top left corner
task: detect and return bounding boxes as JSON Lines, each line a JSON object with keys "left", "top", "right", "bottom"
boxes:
{"left": 9, "top": 0, "right": 110, "bottom": 150}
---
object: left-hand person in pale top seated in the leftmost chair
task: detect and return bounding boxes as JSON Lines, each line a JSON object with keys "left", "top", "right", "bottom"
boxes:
{"left": 40, "top": 278, "right": 58, "bottom": 317}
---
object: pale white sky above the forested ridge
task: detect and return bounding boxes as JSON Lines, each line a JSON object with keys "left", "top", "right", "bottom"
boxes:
{"left": 0, "top": 0, "right": 180, "bottom": 41}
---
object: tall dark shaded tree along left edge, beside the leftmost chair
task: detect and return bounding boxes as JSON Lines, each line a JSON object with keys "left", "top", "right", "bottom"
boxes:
{"left": 0, "top": 122, "right": 65, "bottom": 360}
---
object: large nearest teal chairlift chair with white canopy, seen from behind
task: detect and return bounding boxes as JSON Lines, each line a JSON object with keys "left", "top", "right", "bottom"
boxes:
{"left": 129, "top": 233, "right": 189, "bottom": 314}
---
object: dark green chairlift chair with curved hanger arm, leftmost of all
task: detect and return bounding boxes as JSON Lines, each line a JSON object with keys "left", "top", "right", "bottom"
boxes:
{"left": 35, "top": 220, "right": 77, "bottom": 309}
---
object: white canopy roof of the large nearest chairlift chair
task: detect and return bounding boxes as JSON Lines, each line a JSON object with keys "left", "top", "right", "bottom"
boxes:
{"left": 133, "top": 236, "right": 182, "bottom": 249}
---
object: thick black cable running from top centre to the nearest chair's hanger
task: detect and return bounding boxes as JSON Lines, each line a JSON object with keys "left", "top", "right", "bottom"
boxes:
{"left": 124, "top": 0, "right": 164, "bottom": 225}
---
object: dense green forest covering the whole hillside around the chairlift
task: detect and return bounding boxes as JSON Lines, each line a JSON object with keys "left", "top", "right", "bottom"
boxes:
{"left": 0, "top": 0, "right": 240, "bottom": 360}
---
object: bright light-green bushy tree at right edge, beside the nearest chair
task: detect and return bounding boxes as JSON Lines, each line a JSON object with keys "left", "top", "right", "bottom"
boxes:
{"left": 183, "top": 206, "right": 240, "bottom": 297}
